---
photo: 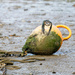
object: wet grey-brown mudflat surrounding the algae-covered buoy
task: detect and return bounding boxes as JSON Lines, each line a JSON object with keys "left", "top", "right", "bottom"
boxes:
{"left": 0, "top": 0, "right": 75, "bottom": 75}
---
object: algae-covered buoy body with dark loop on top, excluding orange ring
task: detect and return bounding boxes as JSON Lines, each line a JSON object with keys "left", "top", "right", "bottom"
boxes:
{"left": 22, "top": 20, "right": 63, "bottom": 55}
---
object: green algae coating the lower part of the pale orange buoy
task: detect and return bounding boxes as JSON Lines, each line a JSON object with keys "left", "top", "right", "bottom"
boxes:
{"left": 22, "top": 31, "right": 62, "bottom": 55}
